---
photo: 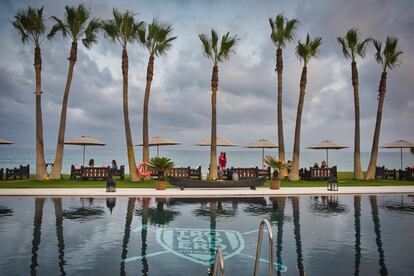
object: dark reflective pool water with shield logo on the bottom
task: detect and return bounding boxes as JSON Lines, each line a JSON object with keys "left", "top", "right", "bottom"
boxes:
{"left": 0, "top": 195, "right": 414, "bottom": 276}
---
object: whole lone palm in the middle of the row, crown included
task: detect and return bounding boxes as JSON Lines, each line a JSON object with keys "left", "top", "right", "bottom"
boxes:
{"left": 199, "top": 29, "right": 239, "bottom": 180}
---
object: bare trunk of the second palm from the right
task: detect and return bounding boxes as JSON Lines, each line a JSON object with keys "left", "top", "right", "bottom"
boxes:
{"left": 351, "top": 61, "right": 364, "bottom": 180}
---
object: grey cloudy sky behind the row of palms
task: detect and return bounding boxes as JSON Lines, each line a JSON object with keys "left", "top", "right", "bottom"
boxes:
{"left": 0, "top": 0, "right": 414, "bottom": 151}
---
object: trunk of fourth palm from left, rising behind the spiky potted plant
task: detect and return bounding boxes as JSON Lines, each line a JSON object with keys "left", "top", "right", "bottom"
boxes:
{"left": 142, "top": 54, "right": 154, "bottom": 165}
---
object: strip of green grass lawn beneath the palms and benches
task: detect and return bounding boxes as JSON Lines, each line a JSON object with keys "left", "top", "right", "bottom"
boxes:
{"left": 0, "top": 172, "right": 414, "bottom": 189}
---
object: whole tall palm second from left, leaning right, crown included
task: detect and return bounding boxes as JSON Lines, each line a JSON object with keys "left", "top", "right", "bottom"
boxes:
{"left": 47, "top": 4, "right": 100, "bottom": 179}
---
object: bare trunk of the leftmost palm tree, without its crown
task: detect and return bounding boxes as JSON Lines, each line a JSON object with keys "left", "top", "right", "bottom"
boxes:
{"left": 34, "top": 46, "right": 47, "bottom": 180}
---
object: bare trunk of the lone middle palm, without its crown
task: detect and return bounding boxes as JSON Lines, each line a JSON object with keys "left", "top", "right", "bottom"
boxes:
{"left": 209, "top": 64, "right": 218, "bottom": 180}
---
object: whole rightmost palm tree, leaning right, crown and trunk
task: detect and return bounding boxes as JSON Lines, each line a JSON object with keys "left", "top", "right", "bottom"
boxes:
{"left": 365, "top": 36, "right": 403, "bottom": 180}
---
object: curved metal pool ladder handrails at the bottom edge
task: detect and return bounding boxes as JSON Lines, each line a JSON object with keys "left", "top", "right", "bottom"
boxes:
{"left": 213, "top": 219, "right": 274, "bottom": 276}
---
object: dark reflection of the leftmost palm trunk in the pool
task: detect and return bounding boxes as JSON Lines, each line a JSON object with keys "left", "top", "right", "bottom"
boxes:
{"left": 30, "top": 198, "right": 45, "bottom": 275}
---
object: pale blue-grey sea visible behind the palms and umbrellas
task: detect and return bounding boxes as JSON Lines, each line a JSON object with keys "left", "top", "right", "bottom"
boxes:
{"left": 0, "top": 146, "right": 414, "bottom": 173}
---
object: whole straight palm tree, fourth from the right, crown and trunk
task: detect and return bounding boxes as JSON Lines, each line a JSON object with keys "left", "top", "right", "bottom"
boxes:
{"left": 269, "top": 14, "right": 299, "bottom": 177}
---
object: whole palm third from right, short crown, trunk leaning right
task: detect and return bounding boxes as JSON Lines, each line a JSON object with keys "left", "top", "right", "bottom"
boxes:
{"left": 289, "top": 34, "right": 322, "bottom": 181}
